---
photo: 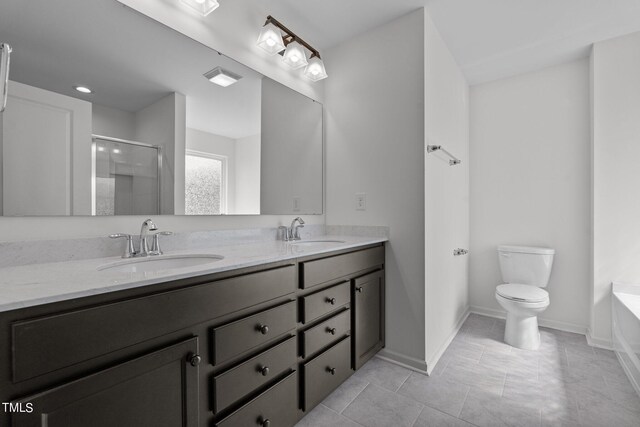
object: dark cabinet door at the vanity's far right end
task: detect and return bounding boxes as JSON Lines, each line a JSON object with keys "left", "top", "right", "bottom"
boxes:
{"left": 352, "top": 271, "right": 384, "bottom": 369}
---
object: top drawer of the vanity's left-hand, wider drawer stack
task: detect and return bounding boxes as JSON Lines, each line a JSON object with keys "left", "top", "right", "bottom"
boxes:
{"left": 212, "top": 301, "right": 297, "bottom": 365}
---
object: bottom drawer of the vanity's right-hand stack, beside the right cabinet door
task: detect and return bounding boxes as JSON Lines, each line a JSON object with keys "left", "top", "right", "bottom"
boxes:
{"left": 304, "top": 337, "right": 353, "bottom": 411}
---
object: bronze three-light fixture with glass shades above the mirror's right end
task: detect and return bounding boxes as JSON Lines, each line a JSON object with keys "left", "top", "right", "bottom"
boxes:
{"left": 257, "top": 15, "right": 327, "bottom": 82}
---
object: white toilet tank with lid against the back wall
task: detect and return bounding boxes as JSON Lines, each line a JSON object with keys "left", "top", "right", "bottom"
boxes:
{"left": 498, "top": 246, "right": 555, "bottom": 288}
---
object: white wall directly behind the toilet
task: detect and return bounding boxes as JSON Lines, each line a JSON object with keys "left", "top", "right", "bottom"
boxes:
{"left": 470, "top": 59, "right": 590, "bottom": 333}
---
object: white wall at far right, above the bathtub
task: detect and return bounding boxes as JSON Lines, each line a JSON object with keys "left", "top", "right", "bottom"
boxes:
{"left": 590, "top": 33, "right": 640, "bottom": 345}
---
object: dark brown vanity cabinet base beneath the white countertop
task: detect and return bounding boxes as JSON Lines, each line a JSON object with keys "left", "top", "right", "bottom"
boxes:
{"left": 0, "top": 241, "right": 385, "bottom": 427}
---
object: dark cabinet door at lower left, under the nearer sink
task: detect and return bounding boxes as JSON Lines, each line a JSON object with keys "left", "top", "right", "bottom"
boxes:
{"left": 12, "top": 337, "right": 198, "bottom": 427}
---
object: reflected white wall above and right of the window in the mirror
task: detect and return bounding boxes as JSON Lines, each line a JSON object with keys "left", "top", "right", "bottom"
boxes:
{"left": 187, "top": 128, "right": 237, "bottom": 215}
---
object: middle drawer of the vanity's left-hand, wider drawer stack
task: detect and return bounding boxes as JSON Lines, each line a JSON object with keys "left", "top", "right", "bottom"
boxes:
{"left": 212, "top": 337, "right": 297, "bottom": 413}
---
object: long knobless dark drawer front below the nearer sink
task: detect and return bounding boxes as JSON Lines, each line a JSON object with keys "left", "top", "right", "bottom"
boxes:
{"left": 12, "top": 266, "right": 296, "bottom": 382}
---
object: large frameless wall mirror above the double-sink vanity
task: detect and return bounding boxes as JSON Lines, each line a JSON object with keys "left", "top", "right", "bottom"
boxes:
{"left": 0, "top": 0, "right": 323, "bottom": 216}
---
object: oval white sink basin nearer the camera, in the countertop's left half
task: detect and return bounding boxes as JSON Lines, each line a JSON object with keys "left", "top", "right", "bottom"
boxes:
{"left": 98, "top": 254, "right": 224, "bottom": 273}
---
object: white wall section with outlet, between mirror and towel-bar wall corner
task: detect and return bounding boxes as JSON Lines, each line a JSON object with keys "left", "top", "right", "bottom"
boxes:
{"left": 323, "top": 9, "right": 425, "bottom": 369}
